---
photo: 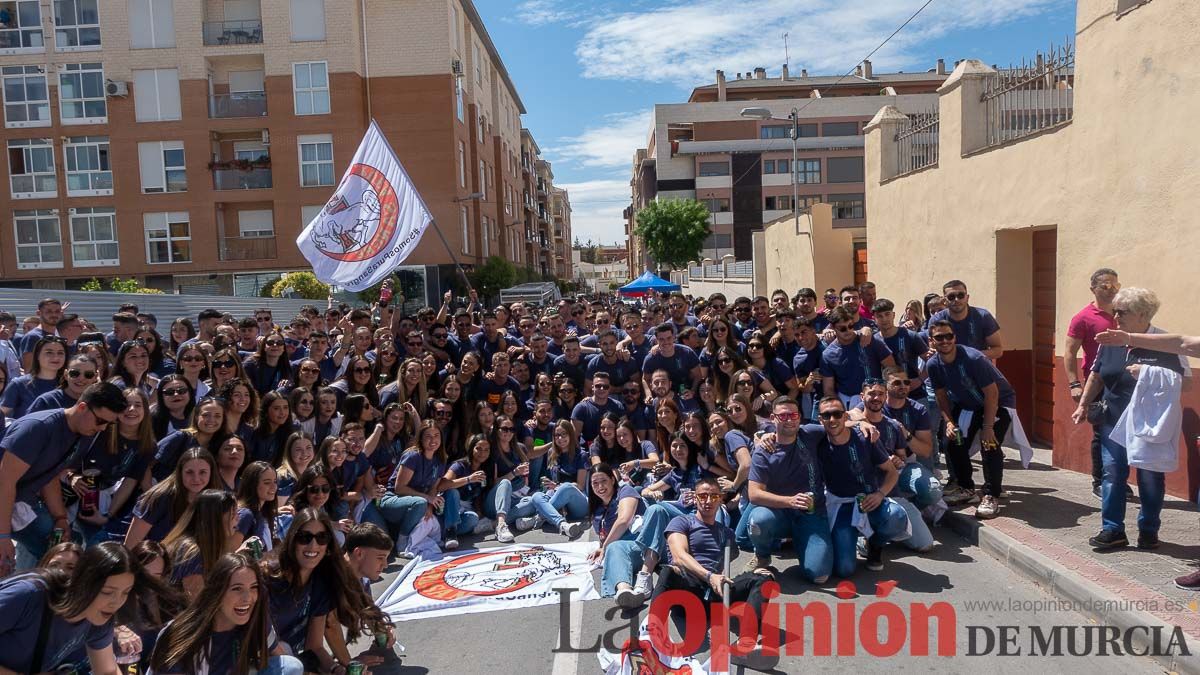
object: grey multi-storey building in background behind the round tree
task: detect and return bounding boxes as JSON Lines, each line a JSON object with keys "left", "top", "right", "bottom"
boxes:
{"left": 626, "top": 60, "right": 947, "bottom": 264}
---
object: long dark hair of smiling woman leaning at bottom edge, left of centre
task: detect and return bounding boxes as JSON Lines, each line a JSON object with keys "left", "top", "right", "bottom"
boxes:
{"left": 150, "top": 554, "right": 270, "bottom": 675}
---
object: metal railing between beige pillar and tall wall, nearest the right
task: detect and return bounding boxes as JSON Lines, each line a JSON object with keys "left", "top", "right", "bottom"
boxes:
{"left": 979, "top": 42, "right": 1075, "bottom": 147}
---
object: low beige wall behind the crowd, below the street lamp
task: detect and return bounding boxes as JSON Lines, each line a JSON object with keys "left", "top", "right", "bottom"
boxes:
{"left": 755, "top": 204, "right": 865, "bottom": 294}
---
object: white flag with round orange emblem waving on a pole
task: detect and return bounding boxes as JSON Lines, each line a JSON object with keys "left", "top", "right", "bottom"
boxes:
{"left": 296, "top": 120, "right": 433, "bottom": 291}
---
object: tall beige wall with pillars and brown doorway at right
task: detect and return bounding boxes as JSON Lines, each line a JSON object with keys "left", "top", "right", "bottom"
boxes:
{"left": 866, "top": 0, "right": 1200, "bottom": 352}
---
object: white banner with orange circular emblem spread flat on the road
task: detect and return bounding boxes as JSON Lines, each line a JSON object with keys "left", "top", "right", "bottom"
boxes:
{"left": 377, "top": 542, "right": 600, "bottom": 621}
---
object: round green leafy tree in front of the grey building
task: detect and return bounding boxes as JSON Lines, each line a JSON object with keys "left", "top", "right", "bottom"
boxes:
{"left": 634, "top": 199, "right": 712, "bottom": 269}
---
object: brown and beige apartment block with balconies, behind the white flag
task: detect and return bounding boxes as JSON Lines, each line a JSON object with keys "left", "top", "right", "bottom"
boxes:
{"left": 0, "top": 0, "right": 566, "bottom": 298}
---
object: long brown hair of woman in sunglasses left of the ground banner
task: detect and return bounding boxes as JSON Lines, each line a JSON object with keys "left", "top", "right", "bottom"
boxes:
{"left": 264, "top": 508, "right": 390, "bottom": 641}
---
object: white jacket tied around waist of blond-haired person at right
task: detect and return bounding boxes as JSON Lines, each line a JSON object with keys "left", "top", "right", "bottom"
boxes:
{"left": 1109, "top": 365, "right": 1183, "bottom": 473}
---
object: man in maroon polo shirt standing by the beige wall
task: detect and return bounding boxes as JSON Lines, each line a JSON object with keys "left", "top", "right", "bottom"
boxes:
{"left": 1062, "top": 268, "right": 1121, "bottom": 498}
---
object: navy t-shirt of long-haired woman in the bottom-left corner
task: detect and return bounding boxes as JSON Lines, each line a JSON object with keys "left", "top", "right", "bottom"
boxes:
{"left": 0, "top": 574, "right": 113, "bottom": 673}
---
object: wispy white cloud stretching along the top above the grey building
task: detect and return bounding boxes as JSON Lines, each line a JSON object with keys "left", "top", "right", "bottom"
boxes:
{"left": 576, "top": 0, "right": 1069, "bottom": 86}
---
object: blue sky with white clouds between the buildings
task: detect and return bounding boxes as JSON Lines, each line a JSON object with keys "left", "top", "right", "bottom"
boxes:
{"left": 475, "top": 0, "right": 1075, "bottom": 244}
